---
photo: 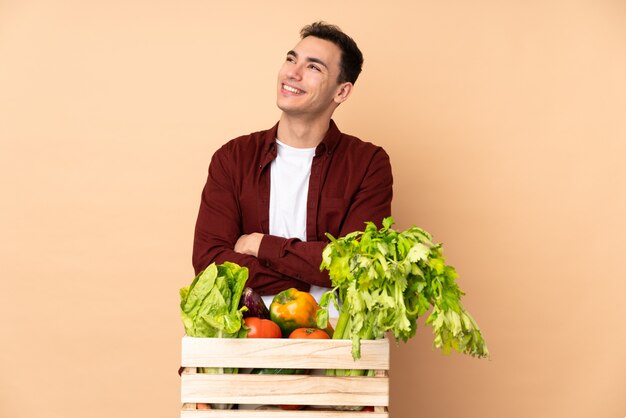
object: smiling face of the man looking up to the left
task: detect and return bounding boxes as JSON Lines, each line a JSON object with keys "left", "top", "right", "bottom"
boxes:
{"left": 276, "top": 36, "right": 345, "bottom": 116}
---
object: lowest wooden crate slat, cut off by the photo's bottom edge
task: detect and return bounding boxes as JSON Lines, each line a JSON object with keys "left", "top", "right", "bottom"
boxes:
{"left": 180, "top": 410, "right": 389, "bottom": 418}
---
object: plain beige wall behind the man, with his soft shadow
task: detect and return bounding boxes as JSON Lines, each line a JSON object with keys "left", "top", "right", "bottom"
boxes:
{"left": 0, "top": 0, "right": 626, "bottom": 418}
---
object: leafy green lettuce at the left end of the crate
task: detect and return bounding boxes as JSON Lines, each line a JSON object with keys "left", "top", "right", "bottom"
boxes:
{"left": 180, "top": 262, "right": 248, "bottom": 409}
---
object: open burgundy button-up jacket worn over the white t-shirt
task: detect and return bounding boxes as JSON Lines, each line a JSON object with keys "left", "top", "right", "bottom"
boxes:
{"left": 193, "top": 120, "right": 393, "bottom": 295}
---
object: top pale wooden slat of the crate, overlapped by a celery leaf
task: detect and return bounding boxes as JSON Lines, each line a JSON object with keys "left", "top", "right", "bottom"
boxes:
{"left": 182, "top": 336, "right": 389, "bottom": 370}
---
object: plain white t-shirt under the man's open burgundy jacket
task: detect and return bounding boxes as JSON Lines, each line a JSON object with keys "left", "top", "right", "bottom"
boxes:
{"left": 263, "top": 139, "right": 339, "bottom": 318}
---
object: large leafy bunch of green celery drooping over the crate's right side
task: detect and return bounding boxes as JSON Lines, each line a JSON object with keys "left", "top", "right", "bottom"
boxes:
{"left": 317, "top": 217, "right": 489, "bottom": 368}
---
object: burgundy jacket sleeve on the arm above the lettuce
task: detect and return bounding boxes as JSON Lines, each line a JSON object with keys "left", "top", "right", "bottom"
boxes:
{"left": 192, "top": 147, "right": 308, "bottom": 295}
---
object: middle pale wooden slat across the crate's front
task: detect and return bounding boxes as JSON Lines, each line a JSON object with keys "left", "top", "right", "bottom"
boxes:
{"left": 181, "top": 373, "right": 389, "bottom": 406}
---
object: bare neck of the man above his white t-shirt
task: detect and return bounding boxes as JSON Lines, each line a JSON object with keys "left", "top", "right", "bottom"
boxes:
{"left": 277, "top": 113, "right": 330, "bottom": 148}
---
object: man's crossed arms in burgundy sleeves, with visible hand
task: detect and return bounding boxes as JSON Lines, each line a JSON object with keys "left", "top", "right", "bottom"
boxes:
{"left": 193, "top": 145, "right": 392, "bottom": 294}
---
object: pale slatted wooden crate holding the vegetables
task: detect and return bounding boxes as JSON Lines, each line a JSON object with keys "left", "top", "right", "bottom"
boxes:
{"left": 181, "top": 336, "right": 389, "bottom": 418}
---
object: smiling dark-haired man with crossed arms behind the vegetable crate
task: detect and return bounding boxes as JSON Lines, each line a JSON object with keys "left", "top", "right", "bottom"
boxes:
{"left": 193, "top": 22, "right": 392, "bottom": 310}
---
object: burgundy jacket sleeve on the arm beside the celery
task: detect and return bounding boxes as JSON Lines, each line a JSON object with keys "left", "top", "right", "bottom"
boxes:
{"left": 258, "top": 148, "right": 393, "bottom": 287}
